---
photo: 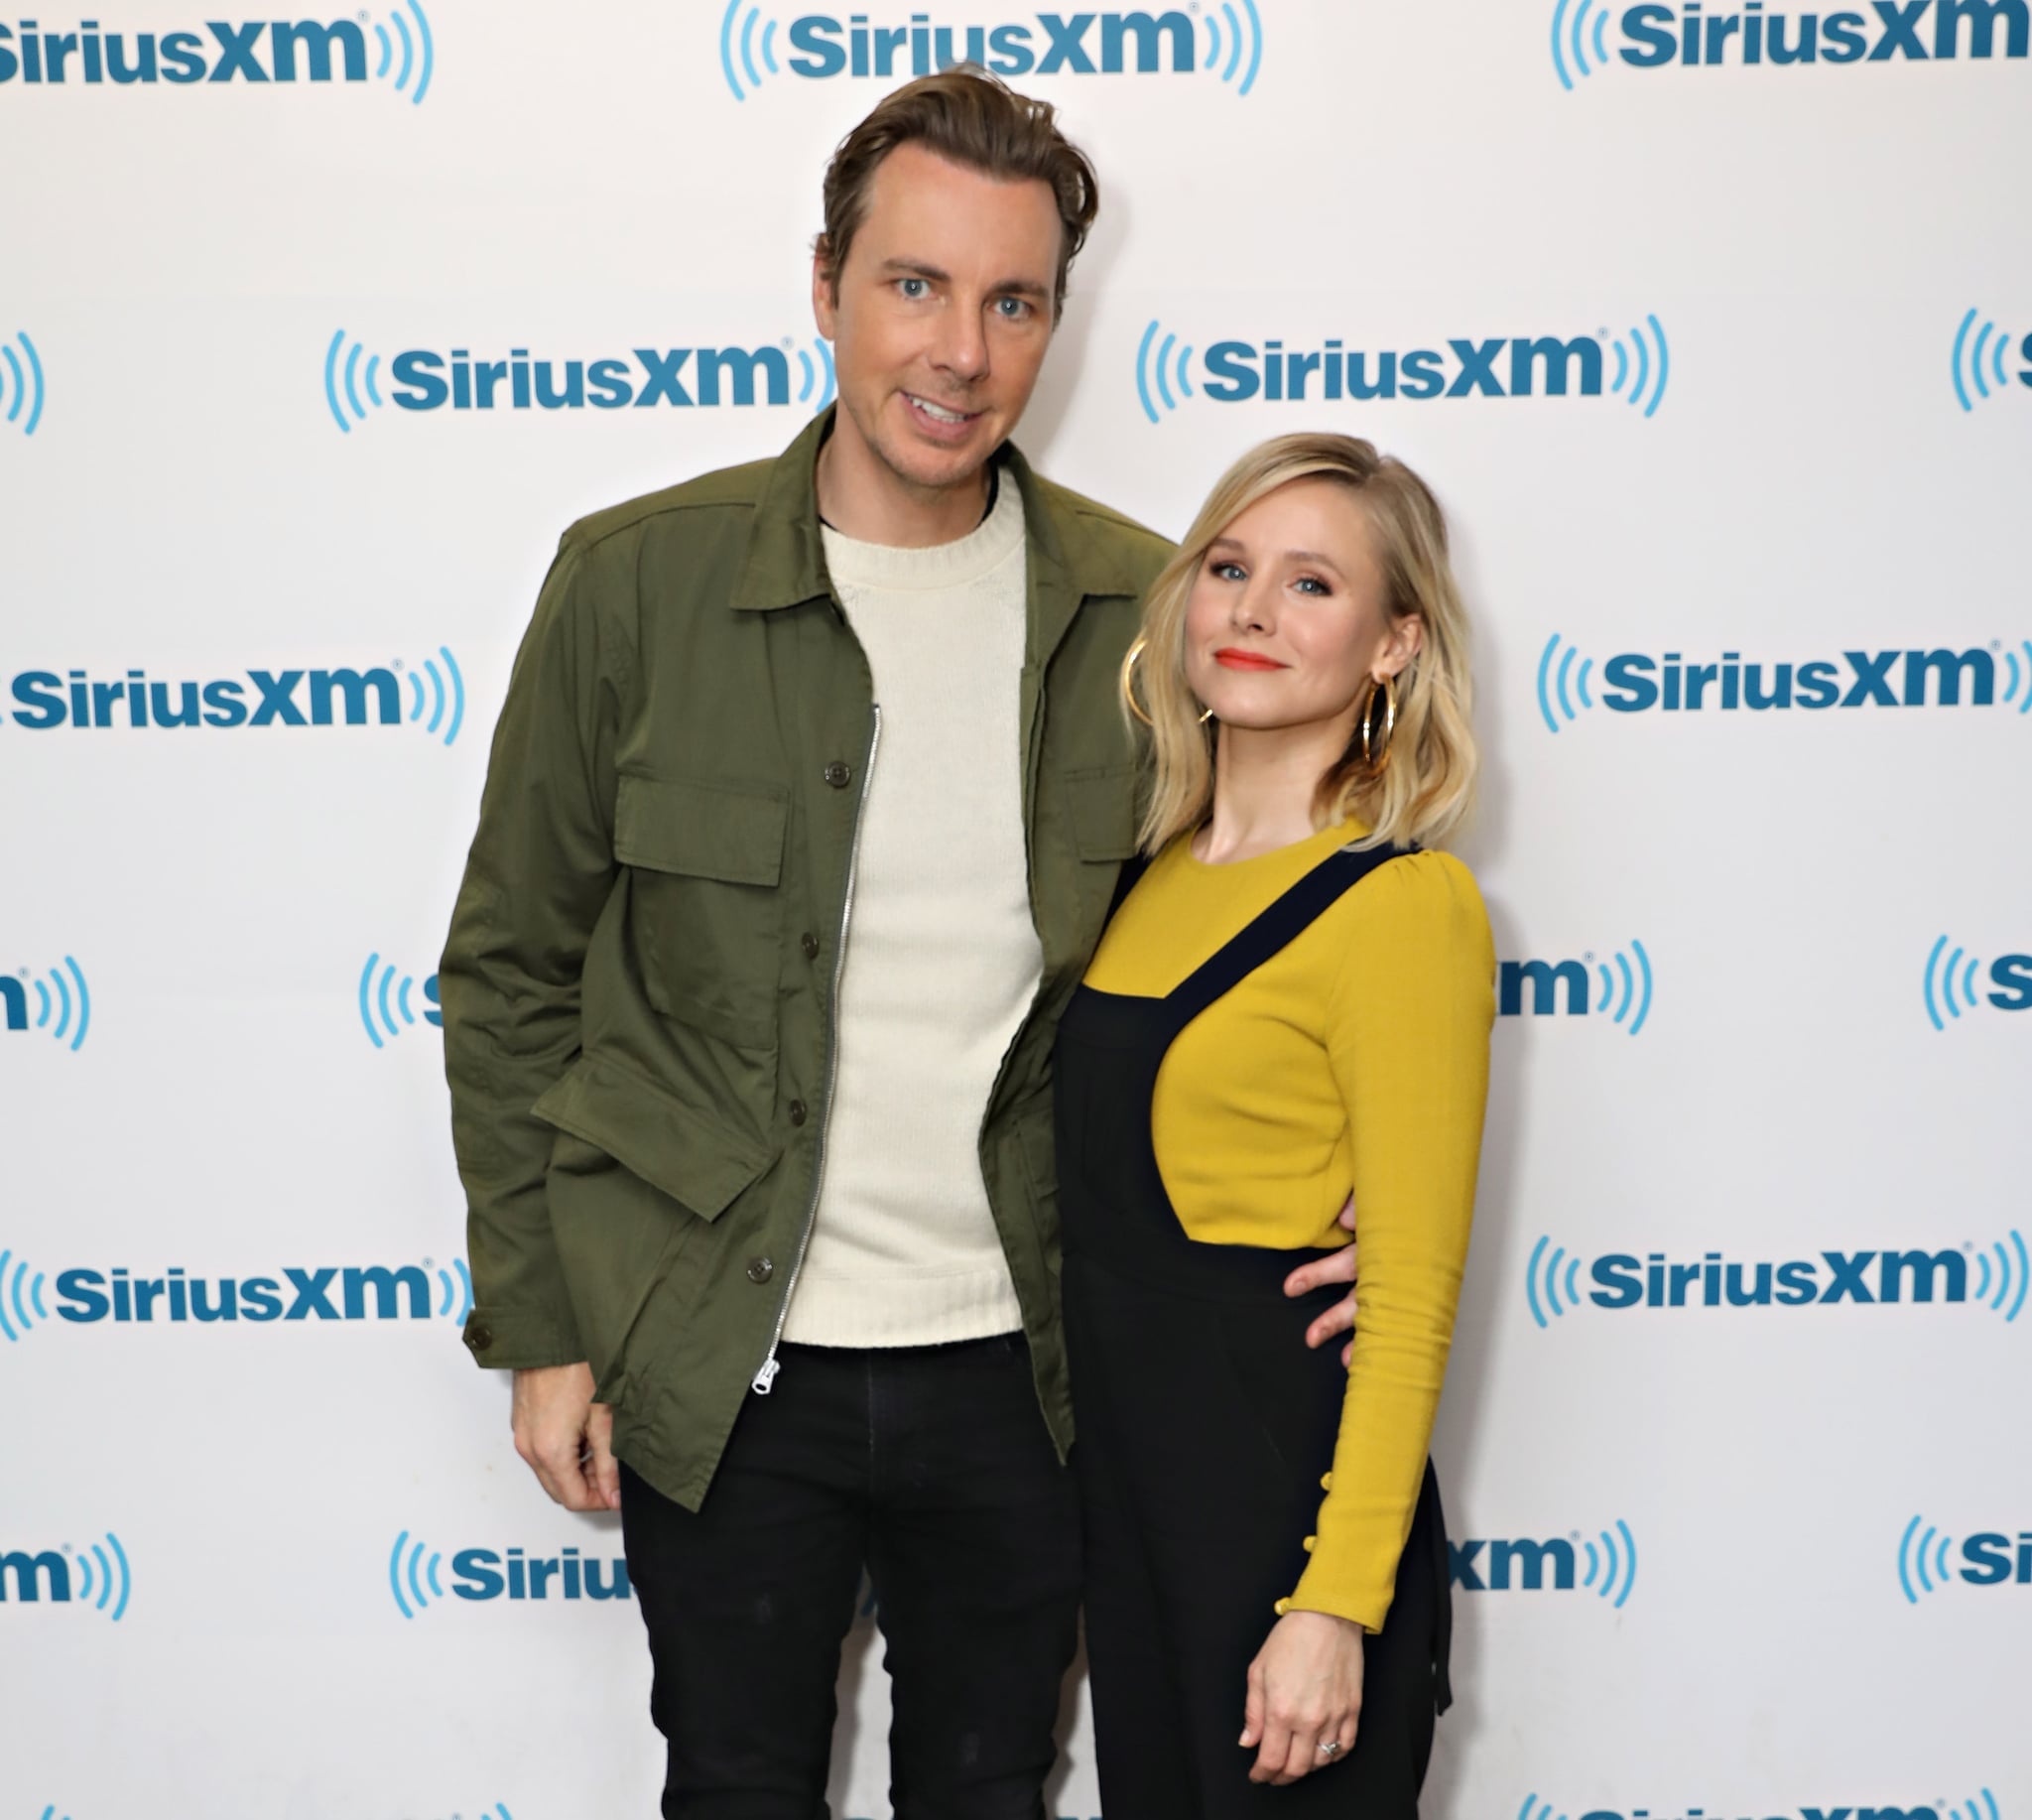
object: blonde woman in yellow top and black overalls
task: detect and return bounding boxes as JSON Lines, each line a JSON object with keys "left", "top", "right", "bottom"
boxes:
{"left": 1057, "top": 435, "right": 1495, "bottom": 1820}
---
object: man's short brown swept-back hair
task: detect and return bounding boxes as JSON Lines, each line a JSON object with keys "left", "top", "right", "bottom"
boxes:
{"left": 813, "top": 63, "right": 1101, "bottom": 321}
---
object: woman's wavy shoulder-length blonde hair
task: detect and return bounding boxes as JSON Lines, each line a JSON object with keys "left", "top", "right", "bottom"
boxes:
{"left": 1130, "top": 433, "right": 1477, "bottom": 853}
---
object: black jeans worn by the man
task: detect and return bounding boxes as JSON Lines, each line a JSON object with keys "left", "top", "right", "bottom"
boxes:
{"left": 622, "top": 1335, "right": 1079, "bottom": 1820}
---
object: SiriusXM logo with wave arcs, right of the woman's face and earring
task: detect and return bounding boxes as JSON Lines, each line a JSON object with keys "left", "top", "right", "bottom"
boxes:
{"left": 1538, "top": 632, "right": 2032, "bottom": 733}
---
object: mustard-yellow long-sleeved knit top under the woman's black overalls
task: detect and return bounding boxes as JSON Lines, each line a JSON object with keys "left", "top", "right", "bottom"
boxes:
{"left": 1087, "top": 825, "right": 1495, "bottom": 1631}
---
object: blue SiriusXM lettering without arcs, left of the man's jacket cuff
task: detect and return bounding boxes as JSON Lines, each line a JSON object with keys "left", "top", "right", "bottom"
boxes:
{"left": 57, "top": 1263, "right": 431, "bottom": 1325}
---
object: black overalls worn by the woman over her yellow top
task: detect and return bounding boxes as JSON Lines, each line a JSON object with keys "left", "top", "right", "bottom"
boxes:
{"left": 1055, "top": 849, "right": 1451, "bottom": 1820}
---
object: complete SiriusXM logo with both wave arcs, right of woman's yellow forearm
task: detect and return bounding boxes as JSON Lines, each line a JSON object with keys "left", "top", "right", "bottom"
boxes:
{"left": 1524, "top": 1227, "right": 2032, "bottom": 1327}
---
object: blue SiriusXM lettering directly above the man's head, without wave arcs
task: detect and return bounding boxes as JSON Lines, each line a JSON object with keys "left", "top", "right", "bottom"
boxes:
{"left": 772, "top": 10, "right": 1195, "bottom": 79}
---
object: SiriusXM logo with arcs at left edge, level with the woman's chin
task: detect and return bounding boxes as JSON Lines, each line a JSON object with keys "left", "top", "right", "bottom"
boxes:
{"left": 10, "top": 644, "right": 465, "bottom": 745}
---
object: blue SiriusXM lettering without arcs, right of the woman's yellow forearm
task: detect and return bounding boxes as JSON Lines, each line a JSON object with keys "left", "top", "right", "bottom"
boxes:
{"left": 1587, "top": 1249, "right": 1969, "bottom": 1308}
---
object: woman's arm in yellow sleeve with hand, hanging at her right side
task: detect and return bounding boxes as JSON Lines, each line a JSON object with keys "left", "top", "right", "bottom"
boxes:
{"left": 1250, "top": 853, "right": 1495, "bottom": 1781}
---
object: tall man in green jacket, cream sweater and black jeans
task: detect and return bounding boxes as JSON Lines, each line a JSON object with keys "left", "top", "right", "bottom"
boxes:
{"left": 439, "top": 71, "right": 1351, "bottom": 1820}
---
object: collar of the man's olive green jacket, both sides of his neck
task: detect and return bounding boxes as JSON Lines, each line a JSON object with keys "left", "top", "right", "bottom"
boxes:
{"left": 729, "top": 404, "right": 1142, "bottom": 617}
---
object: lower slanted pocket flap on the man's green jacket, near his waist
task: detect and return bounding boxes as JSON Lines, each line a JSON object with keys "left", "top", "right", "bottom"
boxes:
{"left": 531, "top": 1054, "right": 774, "bottom": 1219}
